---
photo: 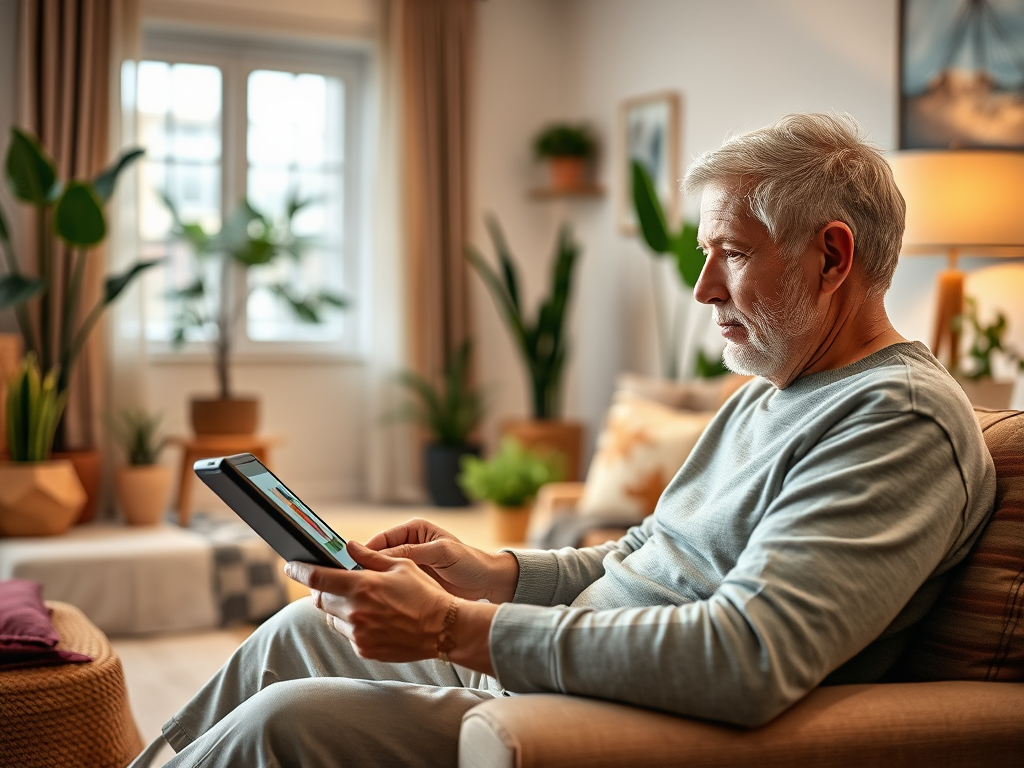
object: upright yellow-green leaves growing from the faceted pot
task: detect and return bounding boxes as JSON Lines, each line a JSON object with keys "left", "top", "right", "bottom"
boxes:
{"left": 4, "top": 352, "right": 68, "bottom": 462}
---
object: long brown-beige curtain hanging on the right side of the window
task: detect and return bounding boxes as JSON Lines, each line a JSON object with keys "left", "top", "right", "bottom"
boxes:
{"left": 400, "top": 0, "right": 477, "bottom": 397}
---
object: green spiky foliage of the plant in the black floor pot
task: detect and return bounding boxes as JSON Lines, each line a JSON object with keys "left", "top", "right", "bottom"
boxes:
{"left": 391, "top": 340, "right": 484, "bottom": 445}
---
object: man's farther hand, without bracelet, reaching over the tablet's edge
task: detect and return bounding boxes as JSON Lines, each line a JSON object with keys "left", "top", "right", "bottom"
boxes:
{"left": 367, "top": 519, "right": 519, "bottom": 603}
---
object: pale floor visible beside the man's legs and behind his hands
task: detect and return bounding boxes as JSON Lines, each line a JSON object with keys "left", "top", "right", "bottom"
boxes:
{"left": 111, "top": 506, "right": 502, "bottom": 765}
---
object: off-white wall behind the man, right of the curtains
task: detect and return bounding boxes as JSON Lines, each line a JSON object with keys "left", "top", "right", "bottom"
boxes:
{"left": 476, "top": 0, "right": 1024, "bottom": 462}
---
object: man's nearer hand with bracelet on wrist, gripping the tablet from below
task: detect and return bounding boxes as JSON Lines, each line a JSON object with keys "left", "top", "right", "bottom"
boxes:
{"left": 285, "top": 542, "right": 497, "bottom": 674}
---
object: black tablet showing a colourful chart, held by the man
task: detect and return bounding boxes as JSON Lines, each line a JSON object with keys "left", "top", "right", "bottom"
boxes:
{"left": 193, "top": 454, "right": 360, "bottom": 570}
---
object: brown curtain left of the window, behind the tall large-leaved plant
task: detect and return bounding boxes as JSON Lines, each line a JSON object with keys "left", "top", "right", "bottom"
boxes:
{"left": 17, "top": 0, "right": 138, "bottom": 447}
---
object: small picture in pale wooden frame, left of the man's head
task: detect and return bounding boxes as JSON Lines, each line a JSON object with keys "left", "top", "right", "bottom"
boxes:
{"left": 617, "top": 91, "right": 680, "bottom": 234}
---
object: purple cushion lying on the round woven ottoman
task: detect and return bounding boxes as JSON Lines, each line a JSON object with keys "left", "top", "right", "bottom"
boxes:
{"left": 0, "top": 579, "right": 92, "bottom": 669}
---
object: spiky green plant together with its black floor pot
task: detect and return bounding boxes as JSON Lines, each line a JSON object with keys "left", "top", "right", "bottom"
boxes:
{"left": 391, "top": 340, "right": 484, "bottom": 507}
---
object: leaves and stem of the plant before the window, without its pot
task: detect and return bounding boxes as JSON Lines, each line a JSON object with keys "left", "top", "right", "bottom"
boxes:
{"left": 164, "top": 195, "right": 348, "bottom": 399}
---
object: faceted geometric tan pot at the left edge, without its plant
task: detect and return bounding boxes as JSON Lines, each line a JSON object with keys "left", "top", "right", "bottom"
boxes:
{"left": 0, "top": 459, "right": 86, "bottom": 537}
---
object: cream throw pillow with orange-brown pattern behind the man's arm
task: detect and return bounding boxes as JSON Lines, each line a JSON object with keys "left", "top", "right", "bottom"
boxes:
{"left": 578, "top": 392, "right": 714, "bottom": 520}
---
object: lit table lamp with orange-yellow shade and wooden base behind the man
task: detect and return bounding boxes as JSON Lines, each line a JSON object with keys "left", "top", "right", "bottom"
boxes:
{"left": 888, "top": 150, "right": 1024, "bottom": 372}
